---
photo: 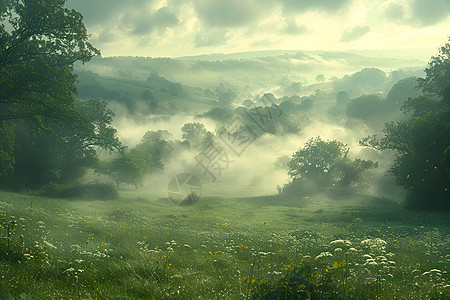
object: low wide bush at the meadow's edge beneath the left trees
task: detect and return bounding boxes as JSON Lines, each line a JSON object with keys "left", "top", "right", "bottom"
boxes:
{"left": 40, "top": 183, "right": 119, "bottom": 200}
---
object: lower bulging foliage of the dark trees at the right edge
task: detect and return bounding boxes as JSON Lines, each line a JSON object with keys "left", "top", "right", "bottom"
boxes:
{"left": 361, "top": 113, "right": 450, "bottom": 209}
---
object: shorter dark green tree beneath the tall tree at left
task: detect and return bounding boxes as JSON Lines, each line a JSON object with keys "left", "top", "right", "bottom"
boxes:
{"left": 1, "top": 100, "right": 124, "bottom": 190}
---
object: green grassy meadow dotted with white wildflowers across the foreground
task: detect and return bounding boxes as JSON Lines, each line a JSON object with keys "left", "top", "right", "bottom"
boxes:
{"left": 0, "top": 191, "right": 450, "bottom": 299}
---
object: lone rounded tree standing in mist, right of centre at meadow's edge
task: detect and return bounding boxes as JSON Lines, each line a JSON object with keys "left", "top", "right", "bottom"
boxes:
{"left": 285, "top": 137, "right": 378, "bottom": 191}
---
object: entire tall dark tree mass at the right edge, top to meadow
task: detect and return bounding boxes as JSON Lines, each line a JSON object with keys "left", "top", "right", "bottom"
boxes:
{"left": 360, "top": 40, "right": 450, "bottom": 210}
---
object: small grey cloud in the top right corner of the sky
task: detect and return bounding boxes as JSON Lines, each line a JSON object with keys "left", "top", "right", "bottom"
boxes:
{"left": 411, "top": 0, "right": 450, "bottom": 26}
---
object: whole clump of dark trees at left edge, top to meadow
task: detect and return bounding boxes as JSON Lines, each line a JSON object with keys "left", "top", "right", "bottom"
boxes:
{"left": 0, "top": 0, "right": 124, "bottom": 189}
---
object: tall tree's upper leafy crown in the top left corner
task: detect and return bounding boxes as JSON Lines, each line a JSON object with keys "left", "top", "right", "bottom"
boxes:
{"left": 0, "top": 0, "right": 100, "bottom": 175}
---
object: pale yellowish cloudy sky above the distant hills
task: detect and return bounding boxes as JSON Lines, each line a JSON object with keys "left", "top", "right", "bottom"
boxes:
{"left": 66, "top": 0, "right": 450, "bottom": 57}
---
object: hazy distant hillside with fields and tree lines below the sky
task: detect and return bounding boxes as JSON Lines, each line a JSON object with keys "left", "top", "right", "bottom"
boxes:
{"left": 75, "top": 50, "right": 426, "bottom": 118}
